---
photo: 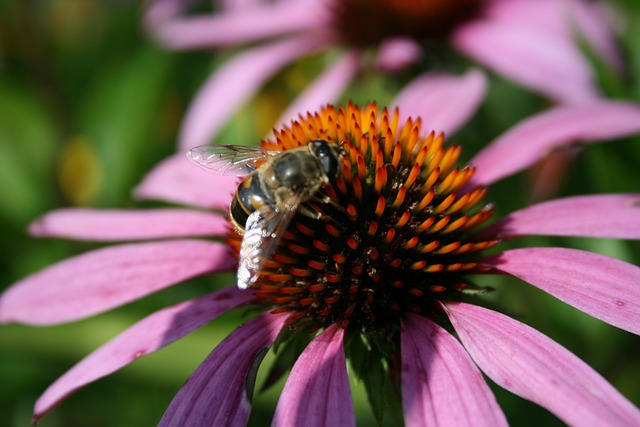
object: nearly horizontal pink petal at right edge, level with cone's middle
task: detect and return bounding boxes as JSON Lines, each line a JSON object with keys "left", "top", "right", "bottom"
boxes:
{"left": 483, "top": 194, "right": 640, "bottom": 239}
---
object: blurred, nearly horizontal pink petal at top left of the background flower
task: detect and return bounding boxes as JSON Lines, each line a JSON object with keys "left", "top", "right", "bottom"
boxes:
{"left": 149, "top": 2, "right": 328, "bottom": 49}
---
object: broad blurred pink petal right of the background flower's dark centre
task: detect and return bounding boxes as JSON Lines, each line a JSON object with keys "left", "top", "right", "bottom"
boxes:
{"left": 452, "top": 20, "right": 599, "bottom": 104}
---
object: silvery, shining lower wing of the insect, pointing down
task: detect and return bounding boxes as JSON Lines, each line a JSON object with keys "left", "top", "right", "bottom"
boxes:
{"left": 238, "top": 194, "right": 302, "bottom": 289}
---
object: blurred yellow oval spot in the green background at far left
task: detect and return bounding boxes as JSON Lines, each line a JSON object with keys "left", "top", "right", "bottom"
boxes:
{"left": 58, "top": 136, "right": 104, "bottom": 206}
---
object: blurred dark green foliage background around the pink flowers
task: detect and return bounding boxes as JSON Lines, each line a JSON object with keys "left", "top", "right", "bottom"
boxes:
{"left": 0, "top": 0, "right": 640, "bottom": 427}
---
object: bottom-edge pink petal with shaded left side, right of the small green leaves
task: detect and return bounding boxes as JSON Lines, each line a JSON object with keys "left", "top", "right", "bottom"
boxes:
{"left": 401, "top": 315, "right": 507, "bottom": 427}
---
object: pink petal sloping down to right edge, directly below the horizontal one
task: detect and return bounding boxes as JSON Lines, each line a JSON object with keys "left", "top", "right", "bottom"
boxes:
{"left": 485, "top": 248, "right": 640, "bottom": 335}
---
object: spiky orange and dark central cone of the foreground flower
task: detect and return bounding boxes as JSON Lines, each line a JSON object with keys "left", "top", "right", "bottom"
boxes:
{"left": 232, "top": 104, "right": 497, "bottom": 329}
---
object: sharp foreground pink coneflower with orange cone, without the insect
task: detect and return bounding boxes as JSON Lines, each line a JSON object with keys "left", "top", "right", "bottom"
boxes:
{"left": 0, "top": 75, "right": 640, "bottom": 426}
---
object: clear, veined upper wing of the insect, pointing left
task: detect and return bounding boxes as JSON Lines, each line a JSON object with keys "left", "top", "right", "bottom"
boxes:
{"left": 187, "top": 144, "right": 280, "bottom": 176}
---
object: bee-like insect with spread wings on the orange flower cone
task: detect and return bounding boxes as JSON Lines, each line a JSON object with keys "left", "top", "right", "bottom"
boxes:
{"left": 187, "top": 139, "right": 344, "bottom": 289}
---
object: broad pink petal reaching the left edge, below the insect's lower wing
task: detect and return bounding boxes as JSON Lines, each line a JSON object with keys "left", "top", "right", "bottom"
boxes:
{"left": 0, "top": 240, "right": 236, "bottom": 325}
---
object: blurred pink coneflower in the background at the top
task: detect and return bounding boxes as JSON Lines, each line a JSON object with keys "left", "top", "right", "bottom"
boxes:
{"left": 145, "top": 0, "right": 621, "bottom": 149}
